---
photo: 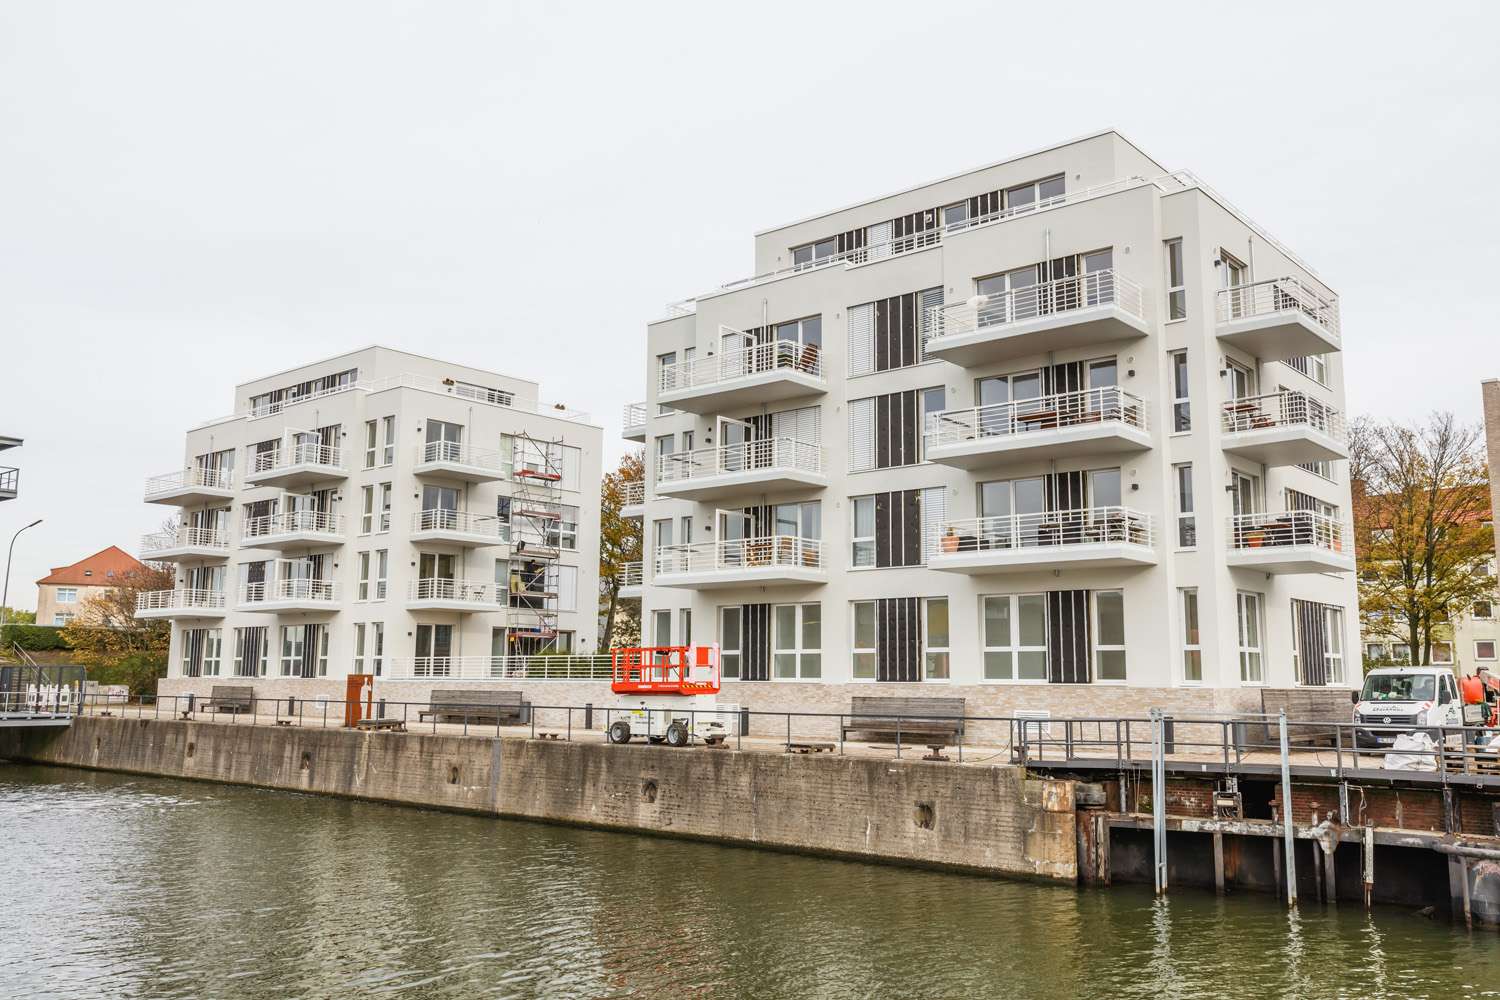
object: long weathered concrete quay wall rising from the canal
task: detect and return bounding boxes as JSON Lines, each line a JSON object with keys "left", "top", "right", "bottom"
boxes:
{"left": 0, "top": 717, "right": 1077, "bottom": 882}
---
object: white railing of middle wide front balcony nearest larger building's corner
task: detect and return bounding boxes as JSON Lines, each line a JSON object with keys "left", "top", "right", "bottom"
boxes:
{"left": 926, "top": 385, "right": 1151, "bottom": 447}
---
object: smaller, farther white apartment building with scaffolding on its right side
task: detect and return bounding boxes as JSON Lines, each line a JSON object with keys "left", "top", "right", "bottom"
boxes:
{"left": 140, "top": 346, "right": 602, "bottom": 700}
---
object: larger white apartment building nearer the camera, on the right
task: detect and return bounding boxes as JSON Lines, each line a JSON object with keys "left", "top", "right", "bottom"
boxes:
{"left": 626, "top": 132, "right": 1359, "bottom": 717}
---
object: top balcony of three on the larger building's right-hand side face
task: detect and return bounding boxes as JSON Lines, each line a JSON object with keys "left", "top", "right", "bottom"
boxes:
{"left": 1217, "top": 277, "right": 1341, "bottom": 361}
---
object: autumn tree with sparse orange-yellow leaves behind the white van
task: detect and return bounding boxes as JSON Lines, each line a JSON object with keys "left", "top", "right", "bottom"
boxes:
{"left": 1349, "top": 412, "right": 1494, "bottom": 666}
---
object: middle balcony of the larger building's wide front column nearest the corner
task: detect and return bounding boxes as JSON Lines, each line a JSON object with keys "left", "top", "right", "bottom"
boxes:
{"left": 926, "top": 385, "right": 1151, "bottom": 469}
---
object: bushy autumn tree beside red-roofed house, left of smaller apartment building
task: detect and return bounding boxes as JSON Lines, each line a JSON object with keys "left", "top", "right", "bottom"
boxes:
{"left": 63, "top": 564, "right": 173, "bottom": 694}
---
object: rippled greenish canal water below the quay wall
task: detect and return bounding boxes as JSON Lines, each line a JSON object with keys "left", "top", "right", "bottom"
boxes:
{"left": 0, "top": 765, "right": 1500, "bottom": 1000}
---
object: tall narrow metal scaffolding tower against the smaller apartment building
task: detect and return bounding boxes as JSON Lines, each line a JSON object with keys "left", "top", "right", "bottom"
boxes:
{"left": 506, "top": 430, "right": 563, "bottom": 654}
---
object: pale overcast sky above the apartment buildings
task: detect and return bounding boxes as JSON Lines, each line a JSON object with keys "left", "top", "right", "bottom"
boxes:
{"left": 0, "top": 0, "right": 1500, "bottom": 609}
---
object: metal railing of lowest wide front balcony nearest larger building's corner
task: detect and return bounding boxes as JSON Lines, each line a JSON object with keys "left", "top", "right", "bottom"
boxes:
{"left": 933, "top": 507, "right": 1157, "bottom": 559}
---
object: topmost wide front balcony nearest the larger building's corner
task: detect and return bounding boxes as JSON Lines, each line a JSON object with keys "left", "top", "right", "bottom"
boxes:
{"left": 924, "top": 271, "right": 1146, "bottom": 367}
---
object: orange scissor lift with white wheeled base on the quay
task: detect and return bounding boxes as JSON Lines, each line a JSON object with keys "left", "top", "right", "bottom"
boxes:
{"left": 605, "top": 646, "right": 729, "bottom": 747}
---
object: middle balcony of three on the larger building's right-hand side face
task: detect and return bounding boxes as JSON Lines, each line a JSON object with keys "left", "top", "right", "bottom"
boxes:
{"left": 1220, "top": 391, "right": 1349, "bottom": 465}
